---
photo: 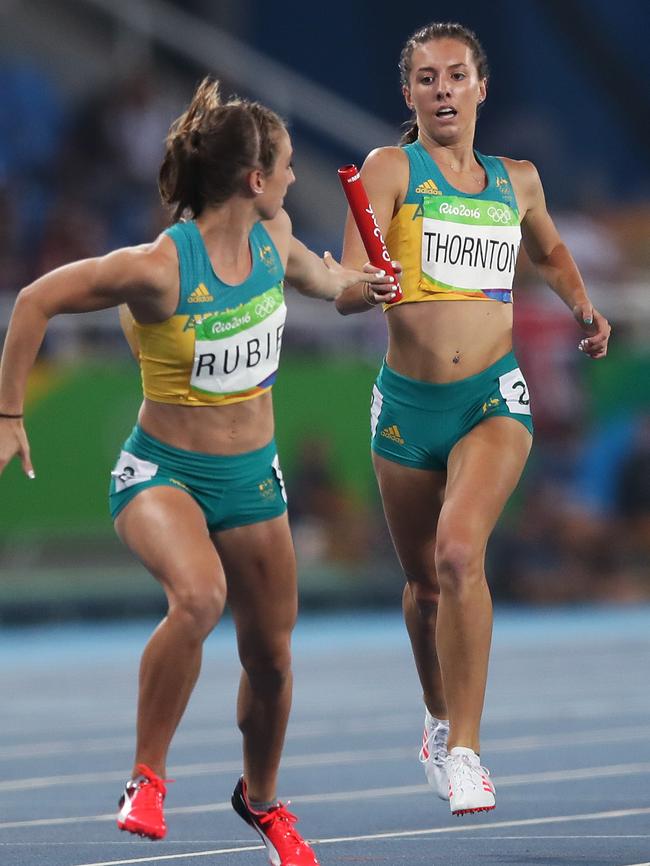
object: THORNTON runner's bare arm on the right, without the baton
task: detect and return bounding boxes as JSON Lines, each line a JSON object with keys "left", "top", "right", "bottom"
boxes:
{"left": 515, "top": 161, "right": 611, "bottom": 358}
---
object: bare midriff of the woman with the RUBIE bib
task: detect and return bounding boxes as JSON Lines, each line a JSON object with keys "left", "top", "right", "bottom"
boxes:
{"left": 138, "top": 391, "right": 274, "bottom": 455}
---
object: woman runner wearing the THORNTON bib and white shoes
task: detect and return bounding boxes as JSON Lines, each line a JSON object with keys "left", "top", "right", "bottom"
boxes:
{"left": 336, "top": 23, "right": 610, "bottom": 814}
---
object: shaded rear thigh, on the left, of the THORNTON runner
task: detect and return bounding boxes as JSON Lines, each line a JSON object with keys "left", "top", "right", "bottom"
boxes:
{"left": 372, "top": 452, "right": 446, "bottom": 585}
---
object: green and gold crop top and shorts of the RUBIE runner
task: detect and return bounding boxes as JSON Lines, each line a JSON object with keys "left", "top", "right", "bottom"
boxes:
{"left": 110, "top": 222, "right": 287, "bottom": 532}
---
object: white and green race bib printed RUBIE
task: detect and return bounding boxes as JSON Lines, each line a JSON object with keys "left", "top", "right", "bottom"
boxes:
{"left": 190, "top": 286, "right": 287, "bottom": 394}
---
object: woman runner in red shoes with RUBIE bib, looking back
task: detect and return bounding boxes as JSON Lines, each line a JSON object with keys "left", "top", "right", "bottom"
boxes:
{"left": 0, "top": 79, "right": 390, "bottom": 866}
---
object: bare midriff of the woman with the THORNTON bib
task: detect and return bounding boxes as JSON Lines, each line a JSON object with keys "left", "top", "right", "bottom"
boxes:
{"left": 386, "top": 300, "right": 512, "bottom": 383}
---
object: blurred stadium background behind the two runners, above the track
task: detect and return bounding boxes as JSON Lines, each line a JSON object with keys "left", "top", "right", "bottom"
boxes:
{"left": 0, "top": 0, "right": 650, "bottom": 624}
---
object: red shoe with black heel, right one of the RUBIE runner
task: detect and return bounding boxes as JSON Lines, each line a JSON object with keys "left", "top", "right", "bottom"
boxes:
{"left": 231, "top": 776, "right": 319, "bottom": 866}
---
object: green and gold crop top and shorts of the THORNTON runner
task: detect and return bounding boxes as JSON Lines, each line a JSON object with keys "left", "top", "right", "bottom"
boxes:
{"left": 371, "top": 141, "right": 533, "bottom": 471}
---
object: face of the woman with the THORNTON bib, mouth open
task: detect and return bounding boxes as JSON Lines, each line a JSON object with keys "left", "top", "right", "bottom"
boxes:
{"left": 403, "top": 38, "right": 486, "bottom": 144}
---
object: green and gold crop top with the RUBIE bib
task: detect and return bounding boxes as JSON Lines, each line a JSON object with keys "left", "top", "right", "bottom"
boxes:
{"left": 134, "top": 221, "right": 287, "bottom": 406}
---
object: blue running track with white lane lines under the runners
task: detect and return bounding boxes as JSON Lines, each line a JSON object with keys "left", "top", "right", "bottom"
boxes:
{"left": 0, "top": 608, "right": 650, "bottom": 866}
